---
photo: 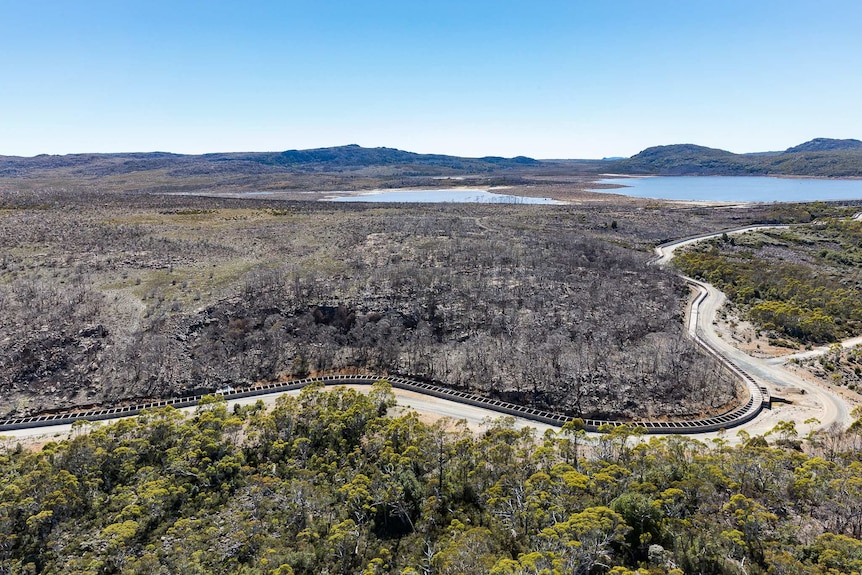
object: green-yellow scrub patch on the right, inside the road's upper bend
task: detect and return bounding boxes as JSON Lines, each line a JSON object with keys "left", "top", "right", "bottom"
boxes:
{"left": 674, "top": 219, "right": 862, "bottom": 343}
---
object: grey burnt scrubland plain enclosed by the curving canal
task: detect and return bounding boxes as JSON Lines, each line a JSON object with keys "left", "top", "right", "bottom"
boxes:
{"left": 0, "top": 190, "right": 767, "bottom": 418}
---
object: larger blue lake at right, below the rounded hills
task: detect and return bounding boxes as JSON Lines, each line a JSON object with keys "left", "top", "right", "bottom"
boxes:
{"left": 593, "top": 176, "right": 862, "bottom": 202}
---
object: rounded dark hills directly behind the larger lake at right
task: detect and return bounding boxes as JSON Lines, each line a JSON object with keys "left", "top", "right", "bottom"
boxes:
{"left": 610, "top": 138, "right": 862, "bottom": 177}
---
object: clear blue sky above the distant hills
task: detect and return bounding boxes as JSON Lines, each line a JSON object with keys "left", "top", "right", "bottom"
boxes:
{"left": 0, "top": 0, "right": 862, "bottom": 158}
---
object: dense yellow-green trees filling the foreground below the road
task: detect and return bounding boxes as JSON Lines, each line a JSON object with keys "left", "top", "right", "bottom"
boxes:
{"left": 5, "top": 383, "right": 862, "bottom": 575}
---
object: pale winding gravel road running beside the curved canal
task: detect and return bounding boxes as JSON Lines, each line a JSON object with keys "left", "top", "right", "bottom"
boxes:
{"left": 0, "top": 226, "right": 853, "bottom": 446}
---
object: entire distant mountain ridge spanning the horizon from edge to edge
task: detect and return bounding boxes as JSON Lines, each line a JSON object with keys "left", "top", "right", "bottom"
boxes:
{"left": 0, "top": 138, "right": 862, "bottom": 181}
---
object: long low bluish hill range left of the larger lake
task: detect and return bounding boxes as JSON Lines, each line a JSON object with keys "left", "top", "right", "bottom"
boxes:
{"left": 0, "top": 144, "right": 540, "bottom": 177}
